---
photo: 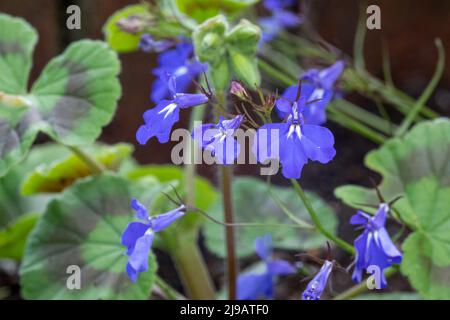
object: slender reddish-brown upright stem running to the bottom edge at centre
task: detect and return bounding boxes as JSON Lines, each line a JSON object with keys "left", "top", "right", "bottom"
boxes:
{"left": 221, "top": 166, "right": 237, "bottom": 300}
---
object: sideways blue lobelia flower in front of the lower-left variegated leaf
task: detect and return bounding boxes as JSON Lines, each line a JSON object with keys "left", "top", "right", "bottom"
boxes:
{"left": 122, "top": 199, "right": 185, "bottom": 282}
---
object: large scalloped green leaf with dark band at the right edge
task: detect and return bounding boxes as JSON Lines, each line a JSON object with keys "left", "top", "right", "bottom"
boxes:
{"left": 335, "top": 118, "right": 450, "bottom": 299}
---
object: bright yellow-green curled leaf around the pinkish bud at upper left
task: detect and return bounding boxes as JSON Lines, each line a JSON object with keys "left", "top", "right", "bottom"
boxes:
{"left": 103, "top": 4, "right": 148, "bottom": 53}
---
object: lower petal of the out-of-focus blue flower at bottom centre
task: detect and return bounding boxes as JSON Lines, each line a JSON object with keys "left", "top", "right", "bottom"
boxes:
{"left": 237, "top": 273, "right": 273, "bottom": 300}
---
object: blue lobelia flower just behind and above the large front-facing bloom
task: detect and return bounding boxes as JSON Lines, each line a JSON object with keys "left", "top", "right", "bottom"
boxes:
{"left": 276, "top": 61, "right": 344, "bottom": 125}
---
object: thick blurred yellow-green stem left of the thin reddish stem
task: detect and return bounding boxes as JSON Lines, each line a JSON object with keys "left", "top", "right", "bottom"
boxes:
{"left": 170, "top": 230, "right": 215, "bottom": 300}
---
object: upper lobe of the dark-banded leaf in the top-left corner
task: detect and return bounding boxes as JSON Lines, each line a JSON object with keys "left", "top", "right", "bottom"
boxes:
{"left": 0, "top": 13, "right": 37, "bottom": 94}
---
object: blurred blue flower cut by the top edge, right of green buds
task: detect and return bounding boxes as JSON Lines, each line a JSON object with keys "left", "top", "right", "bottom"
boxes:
{"left": 259, "top": 0, "right": 303, "bottom": 42}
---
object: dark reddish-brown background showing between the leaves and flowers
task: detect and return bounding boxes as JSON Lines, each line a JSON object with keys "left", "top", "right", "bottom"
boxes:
{"left": 0, "top": 0, "right": 450, "bottom": 299}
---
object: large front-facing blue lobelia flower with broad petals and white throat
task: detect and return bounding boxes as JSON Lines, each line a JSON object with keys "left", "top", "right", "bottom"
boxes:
{"left": 252, "top": 86, "right": 336, "bottom": 179}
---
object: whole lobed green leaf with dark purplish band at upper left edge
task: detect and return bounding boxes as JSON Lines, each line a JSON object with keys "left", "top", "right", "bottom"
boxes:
{"left": 0, "top": 14, "right": 120, "bottom": 176}
